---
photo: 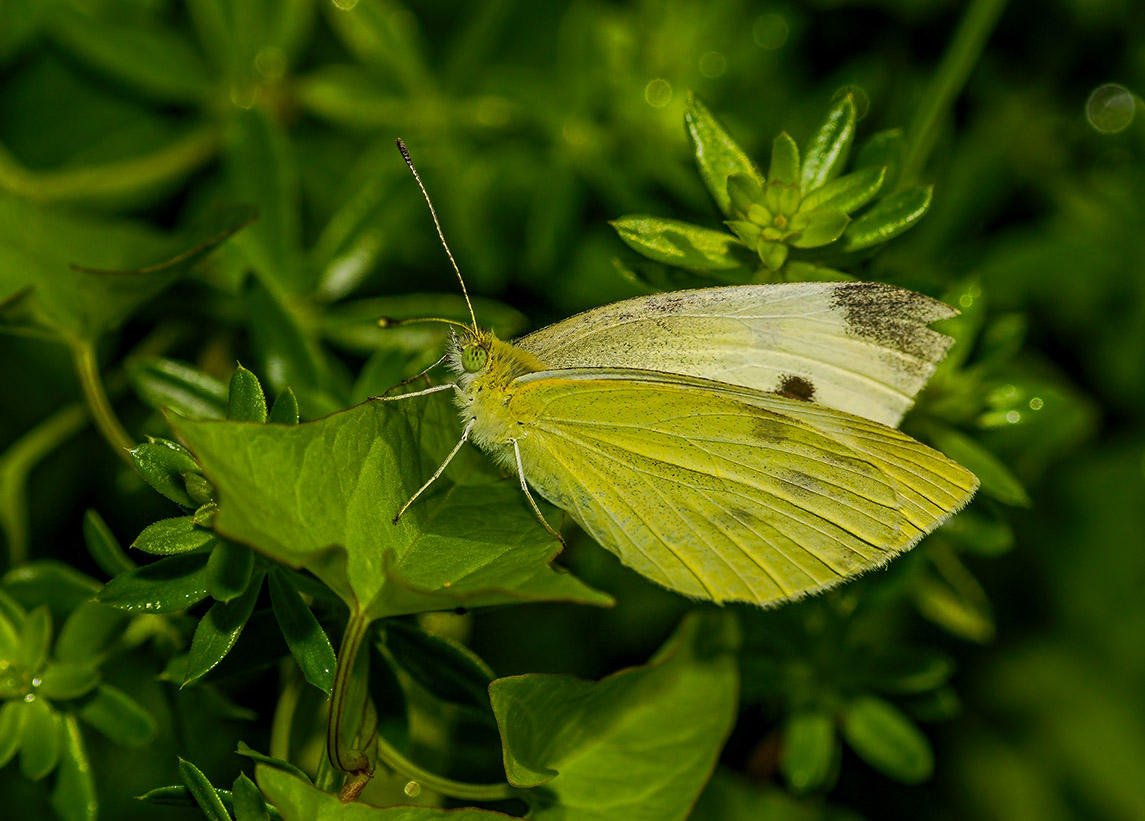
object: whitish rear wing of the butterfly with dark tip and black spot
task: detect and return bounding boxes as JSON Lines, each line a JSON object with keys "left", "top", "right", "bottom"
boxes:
{"left": 513, "top": 282, "right": 957, "bottom": 426}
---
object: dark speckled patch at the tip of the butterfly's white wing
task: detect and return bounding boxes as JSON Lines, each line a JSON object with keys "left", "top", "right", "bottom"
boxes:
{"left": 831, "top": 282, "right": 956, "bottom": 362}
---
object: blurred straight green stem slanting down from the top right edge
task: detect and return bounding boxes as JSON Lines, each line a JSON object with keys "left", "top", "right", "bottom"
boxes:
{"left": 898, "top": 0, "right": 1006, "bottom": 190}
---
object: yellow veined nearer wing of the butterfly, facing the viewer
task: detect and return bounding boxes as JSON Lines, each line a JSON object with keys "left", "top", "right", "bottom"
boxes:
{"left": 508, "top": 369, "right": 978, "bottom": 605}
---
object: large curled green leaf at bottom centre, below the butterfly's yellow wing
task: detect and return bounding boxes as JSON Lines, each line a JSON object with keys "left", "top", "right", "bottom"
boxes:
{"left": 489, "top": 610, "right": 739, "bottom": 821}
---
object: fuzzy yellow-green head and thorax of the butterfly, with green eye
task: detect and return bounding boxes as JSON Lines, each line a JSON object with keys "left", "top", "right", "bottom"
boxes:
{"left": 447, "top": 331, "right": 544, "bottom": 464}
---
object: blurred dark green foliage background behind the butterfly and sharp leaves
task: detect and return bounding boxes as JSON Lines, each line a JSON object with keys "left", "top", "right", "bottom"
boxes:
{"left": 0, "top": 0, "right": 1145, "bottom": 819}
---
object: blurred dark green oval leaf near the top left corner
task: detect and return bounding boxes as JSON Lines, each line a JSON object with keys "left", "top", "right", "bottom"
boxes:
{"left": 47, "top": 5, "right": 213, "bottom": 103}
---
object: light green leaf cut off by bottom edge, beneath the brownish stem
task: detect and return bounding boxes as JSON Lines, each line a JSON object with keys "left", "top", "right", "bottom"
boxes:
{"left": 254, "top": 766, "right": 508, "bottom": 821}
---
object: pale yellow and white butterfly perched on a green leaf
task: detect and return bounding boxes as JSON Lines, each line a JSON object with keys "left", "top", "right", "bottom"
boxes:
{"left": 385, "top": 143, "right": 978, "bottom": 605}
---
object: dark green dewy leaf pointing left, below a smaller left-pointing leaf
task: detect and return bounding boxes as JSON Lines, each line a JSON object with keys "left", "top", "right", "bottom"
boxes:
{"left": 96, "top": 553, "right": 207, "bottom": 613}
